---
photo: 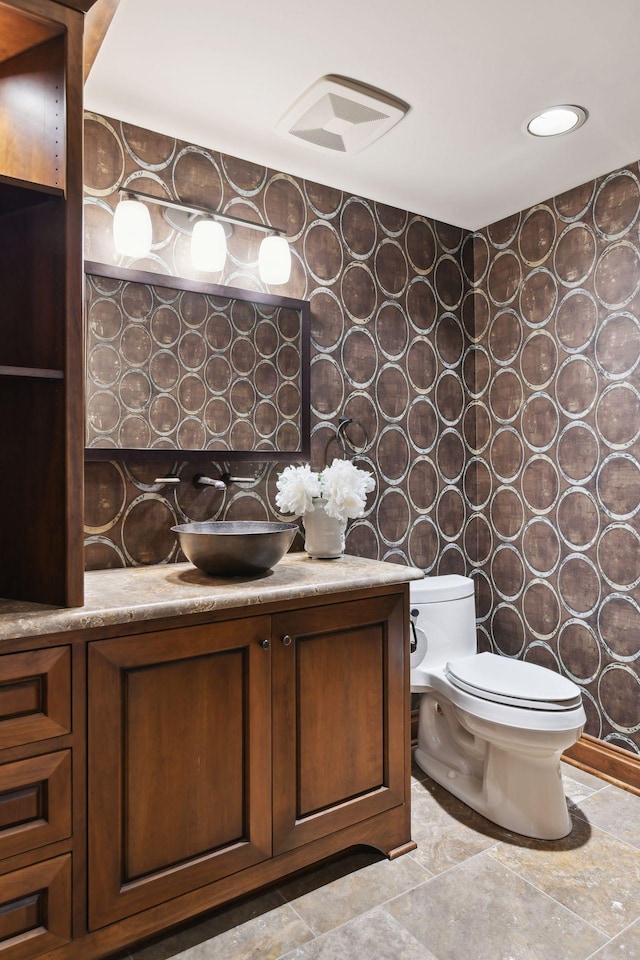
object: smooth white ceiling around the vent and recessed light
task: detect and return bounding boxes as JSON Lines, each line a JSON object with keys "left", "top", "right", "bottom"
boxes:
{"left": 85, "top": 0, "right": 640, "bottom": 230}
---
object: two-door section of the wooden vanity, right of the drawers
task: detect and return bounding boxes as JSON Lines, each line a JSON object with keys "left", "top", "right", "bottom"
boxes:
{"left": 85, "top": 587, "right": 411, "bottom": 944}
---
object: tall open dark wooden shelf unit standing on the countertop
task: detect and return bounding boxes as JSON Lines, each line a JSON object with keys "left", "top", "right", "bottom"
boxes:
{"left": 0, "top": 0, "right": 91, "bottom": 606}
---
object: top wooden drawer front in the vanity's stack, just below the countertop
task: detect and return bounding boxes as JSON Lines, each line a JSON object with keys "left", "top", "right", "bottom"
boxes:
{"left": 0, "top": 647, "right": 71, "bottom": 750}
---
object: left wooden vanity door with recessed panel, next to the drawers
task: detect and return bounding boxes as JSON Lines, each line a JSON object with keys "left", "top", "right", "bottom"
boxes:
{"left": 88, "top": 617, "right": 271, "bottom": 929}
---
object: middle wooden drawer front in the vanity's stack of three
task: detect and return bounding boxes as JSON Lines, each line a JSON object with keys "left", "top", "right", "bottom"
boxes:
{"left": 0, "top": 750, "right": 71, "bottom": 859}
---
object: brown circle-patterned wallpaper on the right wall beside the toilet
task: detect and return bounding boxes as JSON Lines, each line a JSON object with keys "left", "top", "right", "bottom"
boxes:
{"left": 472, "top": 174, "right": 640, "bottom": 752}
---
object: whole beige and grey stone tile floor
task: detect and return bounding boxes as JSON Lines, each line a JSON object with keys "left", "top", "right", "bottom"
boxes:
{"left": 119, "top": 764, "right": 640, "bottom": 960}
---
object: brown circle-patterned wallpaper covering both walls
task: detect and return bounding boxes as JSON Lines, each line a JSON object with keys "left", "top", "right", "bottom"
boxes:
{"left": 85, "top": 114, "right": 640, "bottom": 752}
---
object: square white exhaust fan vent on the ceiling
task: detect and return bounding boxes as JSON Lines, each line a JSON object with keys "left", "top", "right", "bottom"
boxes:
{"left": 276, "top": 76, "right": 409, "bottom": 153}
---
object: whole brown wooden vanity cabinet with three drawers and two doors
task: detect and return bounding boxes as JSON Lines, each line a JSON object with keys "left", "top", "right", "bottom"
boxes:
{"left": 0, "top": 572, "right": 415, "bottom": 960}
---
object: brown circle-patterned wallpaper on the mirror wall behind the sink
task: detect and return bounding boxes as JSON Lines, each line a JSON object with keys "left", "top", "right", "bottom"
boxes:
{"left": 85, "top": 114, "right": 474, "bottom": 573}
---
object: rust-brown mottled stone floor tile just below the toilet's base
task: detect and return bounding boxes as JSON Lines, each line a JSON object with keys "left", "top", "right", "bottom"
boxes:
{"left": 489, "top": 817, "right": 640, "bottom": 937}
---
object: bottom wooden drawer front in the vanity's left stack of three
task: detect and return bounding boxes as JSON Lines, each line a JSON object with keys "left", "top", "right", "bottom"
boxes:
{"left": 0, "top": 855, "right": 71, "bottom": 960}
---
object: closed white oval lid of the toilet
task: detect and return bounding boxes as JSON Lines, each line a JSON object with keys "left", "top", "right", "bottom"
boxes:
{"left": 445, "top": 653, "right": 582, "bottom": 710}
